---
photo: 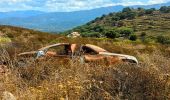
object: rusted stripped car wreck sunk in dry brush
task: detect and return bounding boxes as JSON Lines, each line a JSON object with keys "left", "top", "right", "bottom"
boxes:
{"left": 18, "top": 43, "right": 138, "bottom": 64}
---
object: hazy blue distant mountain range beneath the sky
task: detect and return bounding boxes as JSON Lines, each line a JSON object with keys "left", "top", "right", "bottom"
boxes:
{"left": 0, "top": 3, "right": 170, "bottom": 32}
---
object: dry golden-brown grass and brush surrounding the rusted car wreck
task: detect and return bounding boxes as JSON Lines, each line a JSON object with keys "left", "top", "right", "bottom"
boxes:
{"left": 0, "top": 25, "right": 170, "bottom": 100}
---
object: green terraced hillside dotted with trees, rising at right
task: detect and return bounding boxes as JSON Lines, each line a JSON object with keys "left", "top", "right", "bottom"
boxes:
{"left": 66, "top": 7, "right": 170, "bottom": 44}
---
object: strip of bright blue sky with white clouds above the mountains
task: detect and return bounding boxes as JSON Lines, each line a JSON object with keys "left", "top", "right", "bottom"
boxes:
{"left": 0, "top": 0, "right": 170, "bottom": 12}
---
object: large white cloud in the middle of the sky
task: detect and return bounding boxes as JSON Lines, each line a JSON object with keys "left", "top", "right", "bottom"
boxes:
{"left": 45, "top": 0, "right": 113, "bottom": 11}
